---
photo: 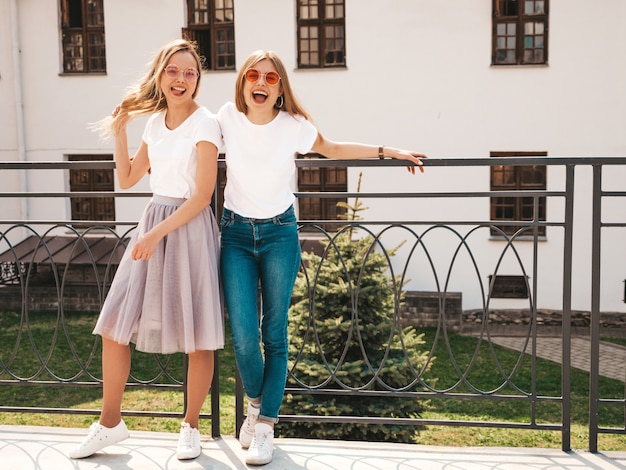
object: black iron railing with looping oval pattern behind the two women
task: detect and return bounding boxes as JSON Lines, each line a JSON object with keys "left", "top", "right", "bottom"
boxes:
{"left": 0, "top": 157, "right": 626, "bottom": 451}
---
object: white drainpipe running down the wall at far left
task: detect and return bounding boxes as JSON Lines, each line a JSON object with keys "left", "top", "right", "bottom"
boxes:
{"left": 11, "top": 0, "right": 30, "bottom": 220}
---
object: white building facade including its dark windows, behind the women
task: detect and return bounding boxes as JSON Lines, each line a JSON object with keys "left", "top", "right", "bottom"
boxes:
{"left": 0, "top": 0, "right": 626, "bottom": 312}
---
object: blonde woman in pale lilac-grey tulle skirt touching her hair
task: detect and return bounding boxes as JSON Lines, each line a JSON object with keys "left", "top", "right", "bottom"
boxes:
{"left": 70, "top": 40, "right": 224, "bottom": 460}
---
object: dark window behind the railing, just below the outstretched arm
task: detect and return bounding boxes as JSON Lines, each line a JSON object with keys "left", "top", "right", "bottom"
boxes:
{"left": 298, "top": 153, "right": 348, "bottom": 232}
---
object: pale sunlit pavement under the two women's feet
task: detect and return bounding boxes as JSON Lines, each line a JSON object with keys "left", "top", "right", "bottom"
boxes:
{"left": 0, "top": 426, "right": 626, "bottom": 470}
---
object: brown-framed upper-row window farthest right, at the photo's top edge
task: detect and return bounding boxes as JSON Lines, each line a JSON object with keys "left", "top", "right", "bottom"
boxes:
{"left": 491, "top": 0, "right": 550, "bottom": 66}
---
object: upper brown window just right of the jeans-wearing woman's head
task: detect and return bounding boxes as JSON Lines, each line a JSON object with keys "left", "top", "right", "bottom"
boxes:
{"left": 296, "top": 0, "right": 347, "bottom": 69}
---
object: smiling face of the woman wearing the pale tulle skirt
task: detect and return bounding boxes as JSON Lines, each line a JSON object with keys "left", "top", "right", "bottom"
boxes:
{"left": 161, "top": 51, "right": 199, "bottom": 103}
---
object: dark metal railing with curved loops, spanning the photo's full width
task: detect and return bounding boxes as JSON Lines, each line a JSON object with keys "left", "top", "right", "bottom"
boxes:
{"left": 0, "top": 157, "right": 626, "bottom": 451}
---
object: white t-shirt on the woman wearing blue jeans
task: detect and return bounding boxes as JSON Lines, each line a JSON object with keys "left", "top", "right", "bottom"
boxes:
{"left": 217, "top": 102, "right": 317, "bottom": 219}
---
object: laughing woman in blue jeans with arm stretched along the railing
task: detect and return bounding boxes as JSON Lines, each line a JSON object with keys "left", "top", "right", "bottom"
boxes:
{"left": 217, "top": 51, "right": 426, "bottom": 465}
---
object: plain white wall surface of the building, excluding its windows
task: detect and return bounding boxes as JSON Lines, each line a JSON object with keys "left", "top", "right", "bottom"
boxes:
{"left": 0, "top": 0, "right": 626, "bottom": 311}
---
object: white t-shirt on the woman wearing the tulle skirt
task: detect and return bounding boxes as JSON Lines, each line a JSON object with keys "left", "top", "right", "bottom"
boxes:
{"left": 142, "top": 106, "right": 222, "bottom": 199}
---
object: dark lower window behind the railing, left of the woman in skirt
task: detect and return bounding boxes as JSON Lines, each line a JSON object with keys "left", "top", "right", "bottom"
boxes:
{"left": 67, "top": 155, "right": 115, "bottom": 228}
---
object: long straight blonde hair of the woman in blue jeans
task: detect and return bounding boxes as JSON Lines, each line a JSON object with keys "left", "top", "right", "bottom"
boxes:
{"left": 235, "top": 50, "right": 311, "bottom": 120}
